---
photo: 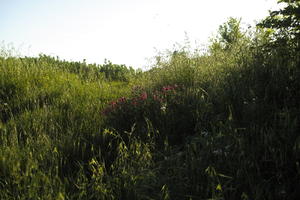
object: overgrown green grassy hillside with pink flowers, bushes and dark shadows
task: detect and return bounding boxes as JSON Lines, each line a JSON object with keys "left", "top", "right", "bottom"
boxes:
{"left": 0, "top": 1, "right": 300, "bottom": 200}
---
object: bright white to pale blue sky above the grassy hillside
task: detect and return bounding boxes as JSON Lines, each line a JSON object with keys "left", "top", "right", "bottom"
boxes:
{"left": 0, "top": 0, "right": 276, "bottom": 68}
